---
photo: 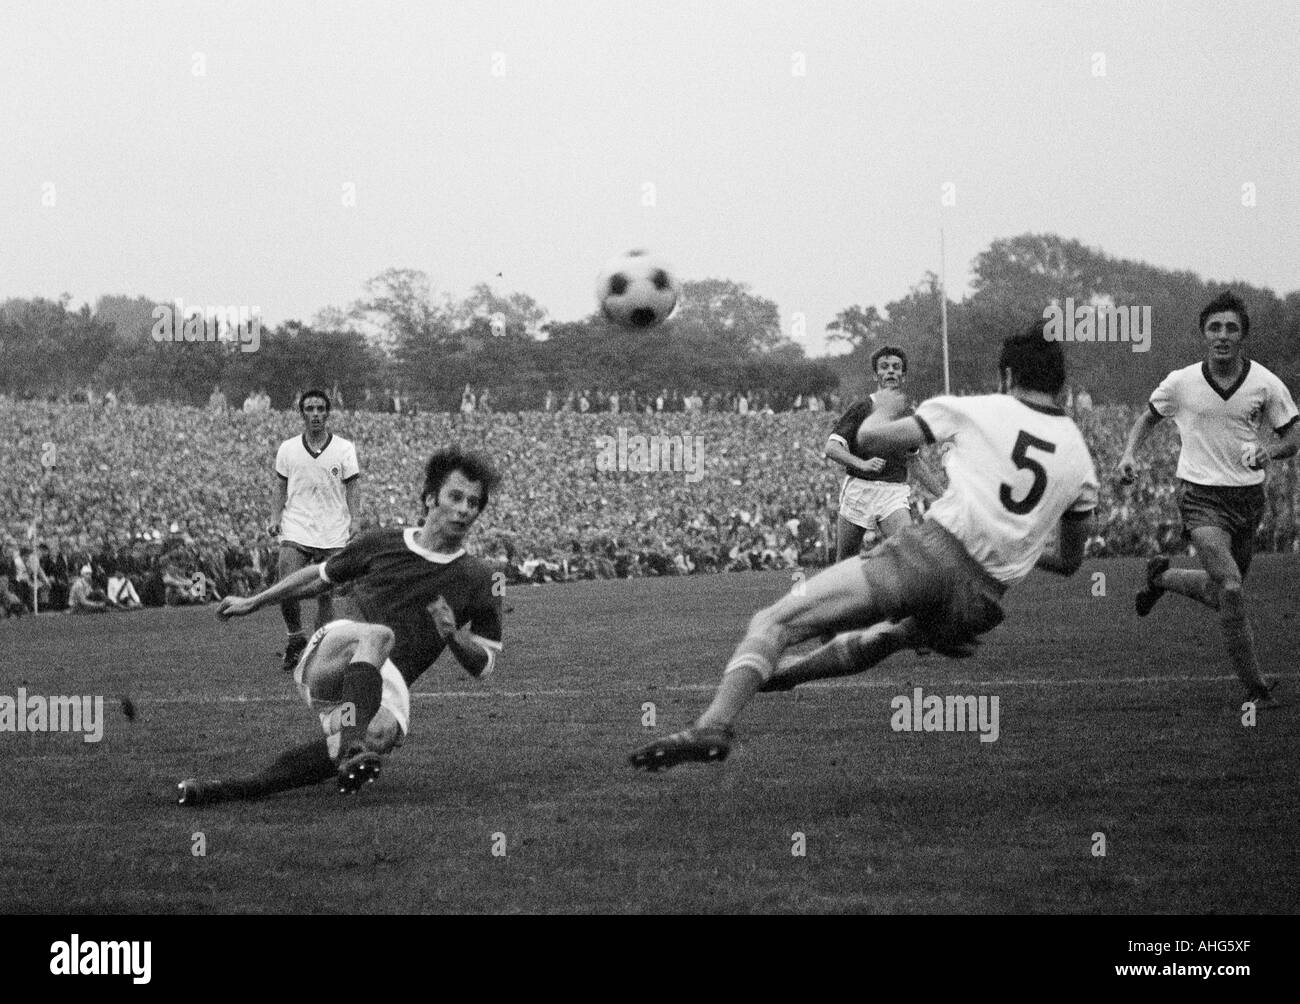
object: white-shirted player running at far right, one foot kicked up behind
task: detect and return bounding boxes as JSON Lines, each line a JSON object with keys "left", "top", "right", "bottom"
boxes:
{"left": 1118, "top": 293, "right": 1300, "bottom": 702}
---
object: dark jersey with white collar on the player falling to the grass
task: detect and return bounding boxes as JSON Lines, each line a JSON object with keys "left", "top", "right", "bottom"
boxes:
{"left": 321, "top": 527, "right": 501, "bottom": 685}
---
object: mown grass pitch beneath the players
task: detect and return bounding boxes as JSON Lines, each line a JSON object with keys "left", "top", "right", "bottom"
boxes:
{"left": 0, "top": 555, "right": 1300, "bottom": 913}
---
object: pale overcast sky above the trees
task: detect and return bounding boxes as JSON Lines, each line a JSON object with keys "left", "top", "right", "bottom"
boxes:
{"left": 0, "top": 0, "right": 1300, "bottom": 354}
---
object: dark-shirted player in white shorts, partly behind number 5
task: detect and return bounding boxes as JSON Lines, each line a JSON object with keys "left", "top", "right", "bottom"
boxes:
{"left": 824, "top": 345, "right": 944, "bottom": 562}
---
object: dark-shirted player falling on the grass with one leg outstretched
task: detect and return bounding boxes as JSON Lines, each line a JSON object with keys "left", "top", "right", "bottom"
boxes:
{"left": 178, "top": 449, "right": 501, "bottom": 805}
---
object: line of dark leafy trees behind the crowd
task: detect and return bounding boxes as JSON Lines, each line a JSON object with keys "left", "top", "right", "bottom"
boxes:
{"left": 0, "top": 234, "right": 1300, "bottom": 411}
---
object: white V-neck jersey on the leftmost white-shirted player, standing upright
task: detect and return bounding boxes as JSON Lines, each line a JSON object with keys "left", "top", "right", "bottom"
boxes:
{"left": 276, "top": 433, "right": 361, "bottom": 548}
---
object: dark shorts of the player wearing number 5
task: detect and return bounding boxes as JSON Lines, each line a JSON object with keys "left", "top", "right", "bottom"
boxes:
{"left": 862, "top": 520, "right": 1006, "bottom": 648}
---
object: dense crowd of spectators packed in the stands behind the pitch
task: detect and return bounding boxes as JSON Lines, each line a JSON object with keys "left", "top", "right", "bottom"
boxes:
{"left": 0, "top": 398, "right": 1300, "bottom": 616}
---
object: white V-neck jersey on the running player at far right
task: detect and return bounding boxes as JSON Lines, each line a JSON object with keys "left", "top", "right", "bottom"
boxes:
{"left": 1149, "top": 359, "right": 1297, "bottom": 486}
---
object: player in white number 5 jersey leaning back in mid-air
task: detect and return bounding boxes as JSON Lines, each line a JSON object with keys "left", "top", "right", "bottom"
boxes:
{"left": 629, "top": 321, "right": 1099, "bottom": 770}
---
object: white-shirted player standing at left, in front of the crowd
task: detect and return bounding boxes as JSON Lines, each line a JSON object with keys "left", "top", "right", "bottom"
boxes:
{"left": 267, "top": 390, "right": 361, "bottom": 672}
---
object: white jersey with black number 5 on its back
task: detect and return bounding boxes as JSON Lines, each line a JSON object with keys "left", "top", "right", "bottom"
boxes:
{"left": 915, "top": 394, "right": 1100, "bottom": 584}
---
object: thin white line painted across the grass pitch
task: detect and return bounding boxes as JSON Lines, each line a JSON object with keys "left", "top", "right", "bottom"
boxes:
{"left": 134, "top": 674, "right": 1295, "bottom": 704}
